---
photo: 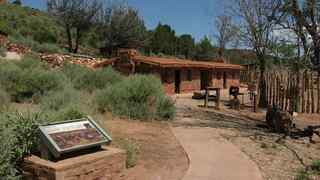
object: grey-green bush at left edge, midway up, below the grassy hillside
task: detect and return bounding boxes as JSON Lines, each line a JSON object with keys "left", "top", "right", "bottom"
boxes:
{"left": 0, "top": 60, "right": 66, "bottom": 102}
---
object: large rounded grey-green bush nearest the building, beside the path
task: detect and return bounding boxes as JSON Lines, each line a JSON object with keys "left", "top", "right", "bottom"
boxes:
{"left": 96, "top": 75, "right": 175, "bottom": 120}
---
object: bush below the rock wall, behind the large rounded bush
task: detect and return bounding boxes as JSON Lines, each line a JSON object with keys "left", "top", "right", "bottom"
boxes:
{"left": 62, "top": 65, "right": 123, "bottom": 92}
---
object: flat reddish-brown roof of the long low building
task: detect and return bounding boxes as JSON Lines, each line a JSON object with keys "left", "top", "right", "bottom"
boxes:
{"left": 133, "top": 56, "right": 241, "bottom": 70}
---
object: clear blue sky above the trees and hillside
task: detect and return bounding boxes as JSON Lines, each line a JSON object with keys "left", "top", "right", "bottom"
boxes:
{"left": 22, "top": 0, "right": 223, "bottom": 40}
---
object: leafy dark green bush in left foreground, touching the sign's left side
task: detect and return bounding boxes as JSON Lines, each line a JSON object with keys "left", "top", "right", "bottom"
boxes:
{"left": 0, "top": 113, "right": 42, "bottom": 180}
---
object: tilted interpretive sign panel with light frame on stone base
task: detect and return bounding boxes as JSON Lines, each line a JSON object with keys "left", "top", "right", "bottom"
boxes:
{"left": 39, "top": 117, "right": 112, "bottom": 158}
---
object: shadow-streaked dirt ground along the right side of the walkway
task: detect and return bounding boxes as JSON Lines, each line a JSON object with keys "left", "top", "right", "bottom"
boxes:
{"left": 173, "top": 96, "right": 320, "bottom": 180}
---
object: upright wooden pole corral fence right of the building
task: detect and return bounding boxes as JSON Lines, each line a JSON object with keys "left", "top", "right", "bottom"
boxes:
{"left": 241, "top": 70, "right": 320, "bottom": 114}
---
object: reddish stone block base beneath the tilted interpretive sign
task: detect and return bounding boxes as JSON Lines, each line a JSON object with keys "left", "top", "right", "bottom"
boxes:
{"left": 24, "top": 147, "right": 126, "bottom": 180}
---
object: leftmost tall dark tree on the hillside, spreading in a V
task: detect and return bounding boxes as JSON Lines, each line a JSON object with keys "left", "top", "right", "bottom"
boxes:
{"left": 47, "top": 0, "right": 103, "bottom": 53}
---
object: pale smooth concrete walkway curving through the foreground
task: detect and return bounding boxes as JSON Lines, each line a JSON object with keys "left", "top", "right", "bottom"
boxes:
{"left": 172, "top": 127, "right": 263, "bottom": 180}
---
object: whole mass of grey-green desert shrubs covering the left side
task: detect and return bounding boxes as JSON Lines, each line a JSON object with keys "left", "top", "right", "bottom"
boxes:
{"left": 0, "top": 56, "right": 175, "bottom": 179}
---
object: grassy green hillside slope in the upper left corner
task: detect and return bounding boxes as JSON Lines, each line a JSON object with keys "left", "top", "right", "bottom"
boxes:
{"left": 0, "top": 4, "right": 63, "bottom": 43}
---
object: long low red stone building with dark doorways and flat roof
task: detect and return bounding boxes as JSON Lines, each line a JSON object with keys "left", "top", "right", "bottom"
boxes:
{"left": 112, "top": 51, "right": 241, "bottom": 94}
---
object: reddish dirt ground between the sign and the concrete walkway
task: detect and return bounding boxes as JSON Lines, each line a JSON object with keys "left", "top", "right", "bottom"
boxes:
{"left": 100, "top": 114, "right": 189, "bottom": 180}
